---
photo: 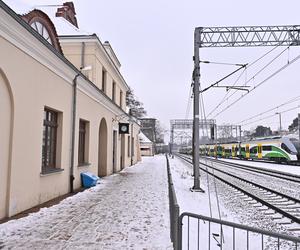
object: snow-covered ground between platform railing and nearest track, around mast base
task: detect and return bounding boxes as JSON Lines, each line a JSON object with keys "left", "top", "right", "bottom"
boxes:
{"left": 170, "top": 157, "right": 298, "bottom": 249}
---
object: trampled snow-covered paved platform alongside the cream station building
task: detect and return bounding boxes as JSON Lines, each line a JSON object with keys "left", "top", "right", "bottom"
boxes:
{"left": 0, "top": 156, "right": 172, "bottom": 250}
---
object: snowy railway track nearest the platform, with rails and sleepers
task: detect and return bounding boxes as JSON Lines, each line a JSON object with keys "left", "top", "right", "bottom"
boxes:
{"left": 177, "top": 155, "right": 300, "bottom": 231}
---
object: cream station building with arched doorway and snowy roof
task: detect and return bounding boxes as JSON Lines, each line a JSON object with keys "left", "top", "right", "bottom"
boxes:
{"left": 0, "top": 0, "right": 140, "bottom": 219}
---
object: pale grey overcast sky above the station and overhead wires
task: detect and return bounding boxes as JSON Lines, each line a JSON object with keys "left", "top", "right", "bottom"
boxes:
{"left": 5, "top": 0, "right": 300, "bottom": 139}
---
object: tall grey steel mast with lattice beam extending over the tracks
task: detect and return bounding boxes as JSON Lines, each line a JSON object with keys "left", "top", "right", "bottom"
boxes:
{"left": 192, "top": 25, "right": 300, "bottom": 191}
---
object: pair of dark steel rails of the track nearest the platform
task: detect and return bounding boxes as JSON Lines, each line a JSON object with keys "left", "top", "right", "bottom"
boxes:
{"left": 177, "top": 155, "right": 300, "bottom": 224}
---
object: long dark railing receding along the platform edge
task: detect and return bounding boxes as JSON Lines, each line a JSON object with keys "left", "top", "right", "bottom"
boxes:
{"left": 166, "top": 154, "right": 179, "bottom": 250}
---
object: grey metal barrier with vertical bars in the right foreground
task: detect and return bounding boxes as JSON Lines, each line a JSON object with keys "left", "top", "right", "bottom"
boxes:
{"left": 177, "top": 213, "right": 300, "bottom": 250}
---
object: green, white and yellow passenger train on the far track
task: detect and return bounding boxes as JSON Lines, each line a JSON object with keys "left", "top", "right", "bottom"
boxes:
{"left": 180, "top": 136, "right": 300, "bottom": 163}
